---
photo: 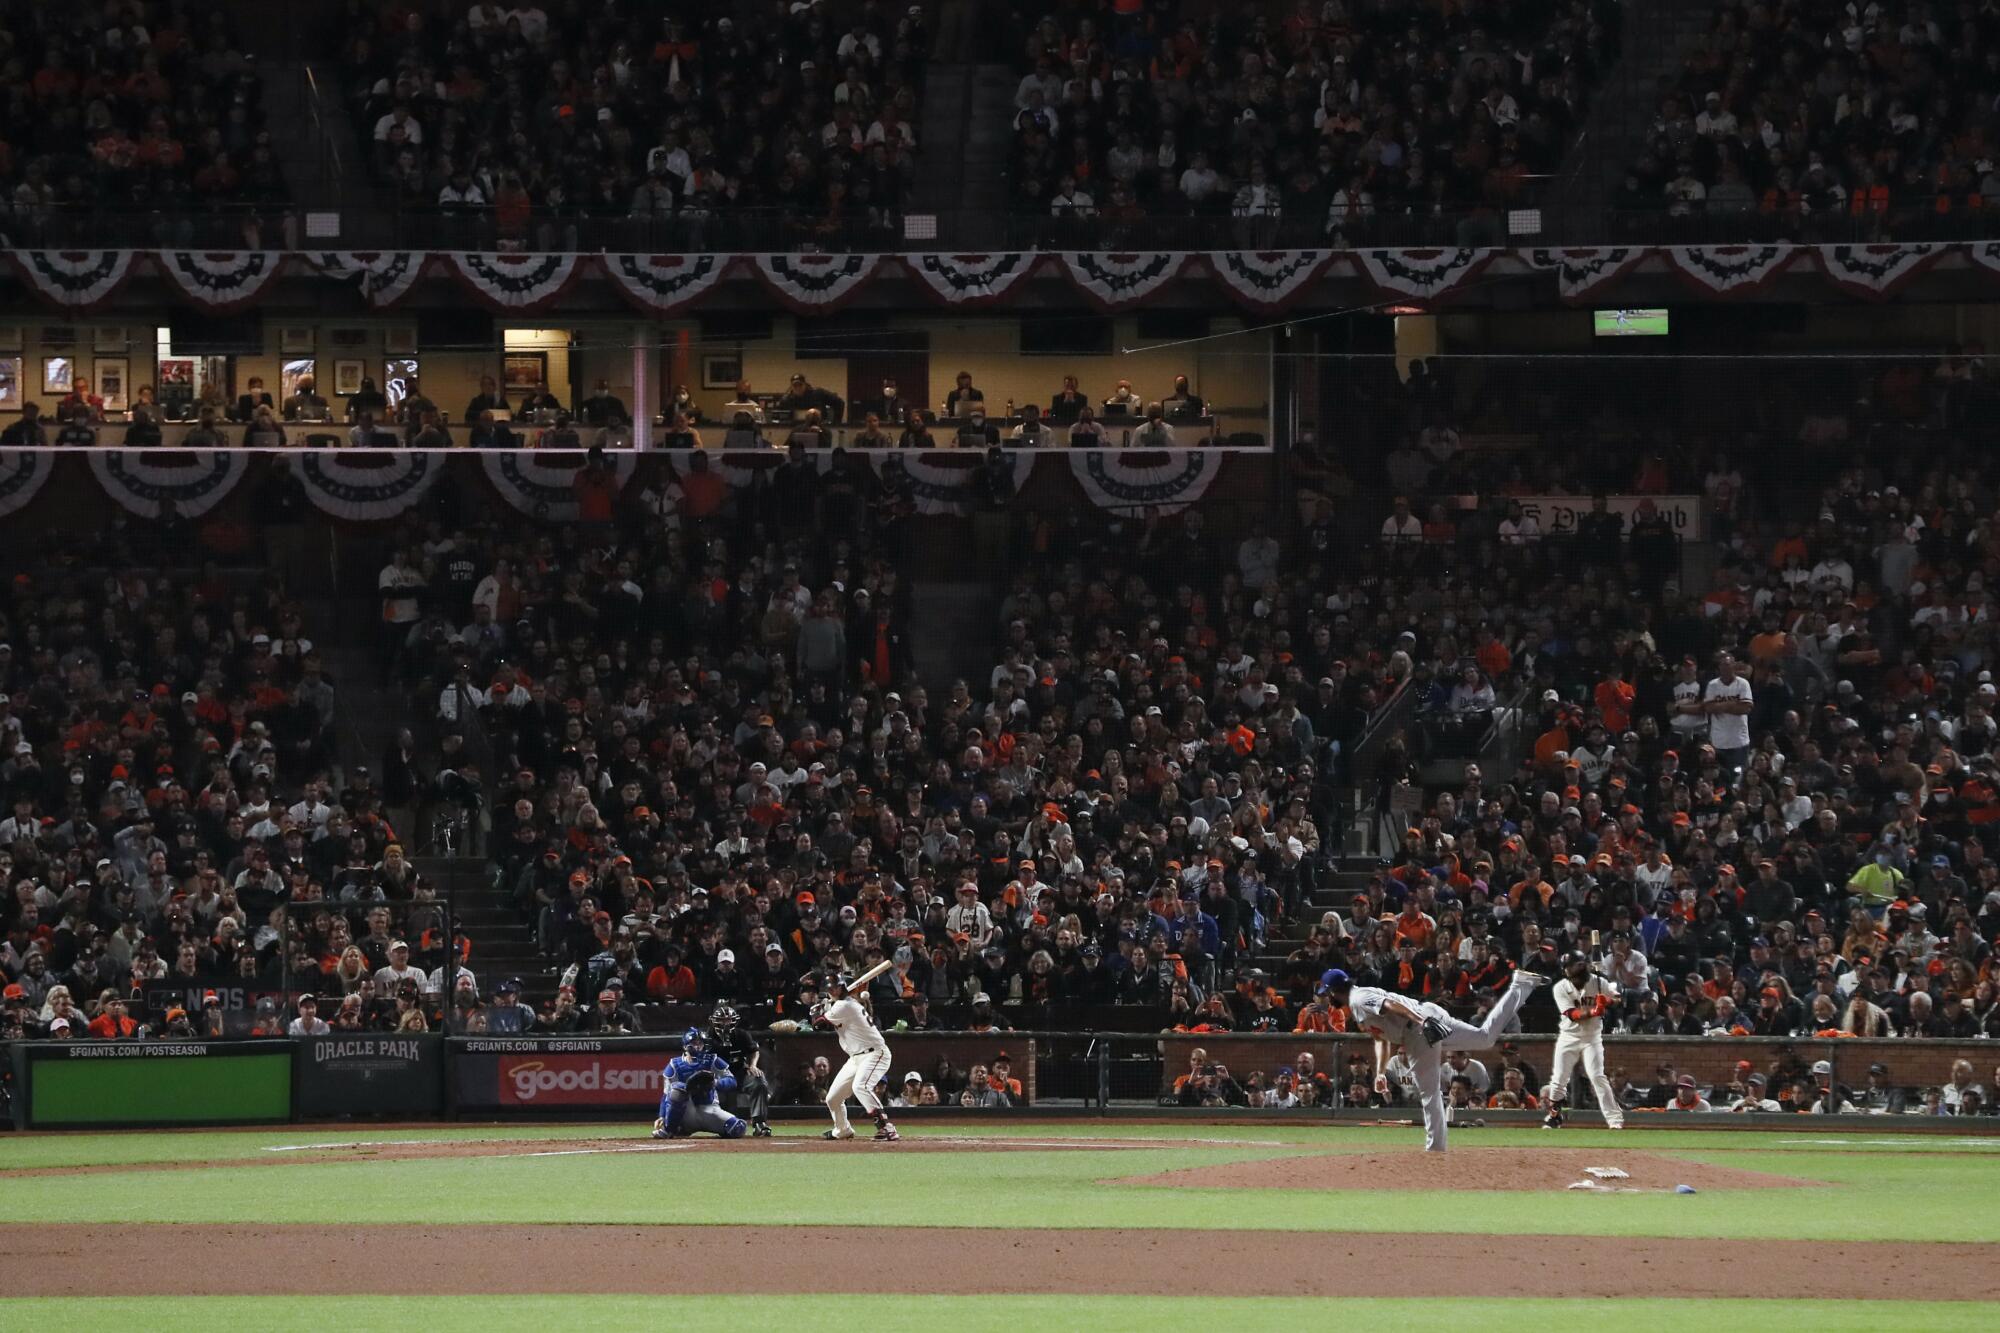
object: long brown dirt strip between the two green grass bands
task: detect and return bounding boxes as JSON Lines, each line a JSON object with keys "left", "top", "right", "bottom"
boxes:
{"left": 0, "top": 1219, "right": 2000, "bottom": 1301}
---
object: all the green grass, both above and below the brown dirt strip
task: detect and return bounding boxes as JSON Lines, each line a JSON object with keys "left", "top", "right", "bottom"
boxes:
{"left": 0, "top": 1121, "right": 2000, "bottom": 1329}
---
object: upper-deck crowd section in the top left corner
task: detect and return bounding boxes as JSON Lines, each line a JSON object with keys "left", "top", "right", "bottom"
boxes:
{"left": 0, "top": 0, "right": 288, "bottom": 250}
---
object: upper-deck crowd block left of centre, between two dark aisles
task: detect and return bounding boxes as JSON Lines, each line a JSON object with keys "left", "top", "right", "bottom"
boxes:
{"left": 332, "top": 0, "right": 930, "bottom": 250}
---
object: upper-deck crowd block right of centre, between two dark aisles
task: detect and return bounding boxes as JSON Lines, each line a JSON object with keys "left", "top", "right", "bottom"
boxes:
{"left": 1012, "top": 0, "right": 1618, "bottom": 244}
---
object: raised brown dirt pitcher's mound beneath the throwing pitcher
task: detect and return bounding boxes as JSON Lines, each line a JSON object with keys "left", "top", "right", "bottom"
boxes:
{"left": 1116, "top": 1147, "right": 1820, "bottom": 1193}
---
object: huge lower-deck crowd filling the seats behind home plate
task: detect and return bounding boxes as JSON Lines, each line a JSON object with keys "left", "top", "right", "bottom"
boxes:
{"left": 0, "top": 334, "right": 2000, "bottom": 1109}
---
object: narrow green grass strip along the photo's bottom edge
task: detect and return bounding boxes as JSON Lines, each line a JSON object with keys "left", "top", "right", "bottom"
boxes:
{"left": 0, "top": 1273, "right": 2000, "bottom": 1333}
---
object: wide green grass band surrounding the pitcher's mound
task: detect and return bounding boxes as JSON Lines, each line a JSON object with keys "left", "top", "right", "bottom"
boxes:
{"left": 6, "top": 1135, "right": 2000, "bottom": 1241}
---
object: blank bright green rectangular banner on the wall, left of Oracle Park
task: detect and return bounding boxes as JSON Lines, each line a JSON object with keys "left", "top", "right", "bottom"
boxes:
{"left": 28, "top": 1041, "right": 292, "bottom": 1129}
